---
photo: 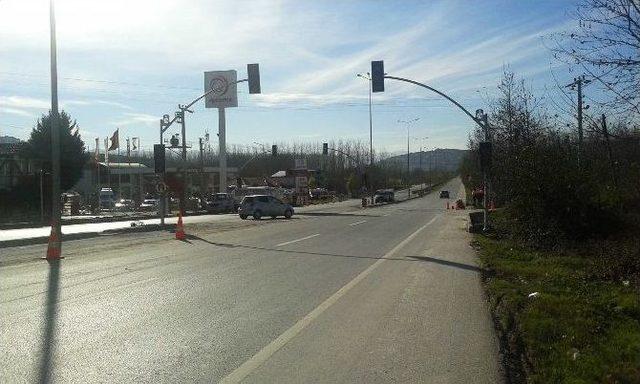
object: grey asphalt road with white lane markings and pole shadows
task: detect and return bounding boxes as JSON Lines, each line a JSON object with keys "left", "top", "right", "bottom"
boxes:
{"left": 0, "top": 180, "right": 501, "bottom": 383}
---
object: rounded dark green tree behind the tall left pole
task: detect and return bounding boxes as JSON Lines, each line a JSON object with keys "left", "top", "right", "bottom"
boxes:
{"left": 24, "top": 111, "right": 89, "bottom": 191}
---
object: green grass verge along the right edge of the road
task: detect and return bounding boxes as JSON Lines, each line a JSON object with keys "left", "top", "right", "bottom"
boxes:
{"left": 474, "top": 235, "right": 640, "bottom": 383}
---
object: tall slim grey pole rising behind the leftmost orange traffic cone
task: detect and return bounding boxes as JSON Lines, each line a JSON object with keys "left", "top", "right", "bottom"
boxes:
{"left": 49, "top": 0, "right": 62, "bottom": 255}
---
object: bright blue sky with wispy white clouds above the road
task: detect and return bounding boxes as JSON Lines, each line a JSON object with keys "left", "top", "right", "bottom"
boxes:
{"left": 0, "top": 0, "right": 575, "bottom": 153}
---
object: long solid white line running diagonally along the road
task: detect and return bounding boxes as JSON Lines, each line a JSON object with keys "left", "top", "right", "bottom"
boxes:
{"left": 219, "top": 215, "right": 441, "bottom": 384}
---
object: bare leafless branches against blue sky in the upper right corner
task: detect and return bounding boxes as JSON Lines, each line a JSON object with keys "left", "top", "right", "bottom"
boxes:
{"left": 553, "top": 0, "right": 640, "bottom": 119}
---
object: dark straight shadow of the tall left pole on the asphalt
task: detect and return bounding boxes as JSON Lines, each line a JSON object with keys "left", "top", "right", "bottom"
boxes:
{"left": 38, "top": 260, "right": 60, "bottom": 383}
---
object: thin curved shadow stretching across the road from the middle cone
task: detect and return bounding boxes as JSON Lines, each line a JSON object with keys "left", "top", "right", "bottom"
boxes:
{"left": 187, "top": 235, "right": 482, "bottom": 273}
